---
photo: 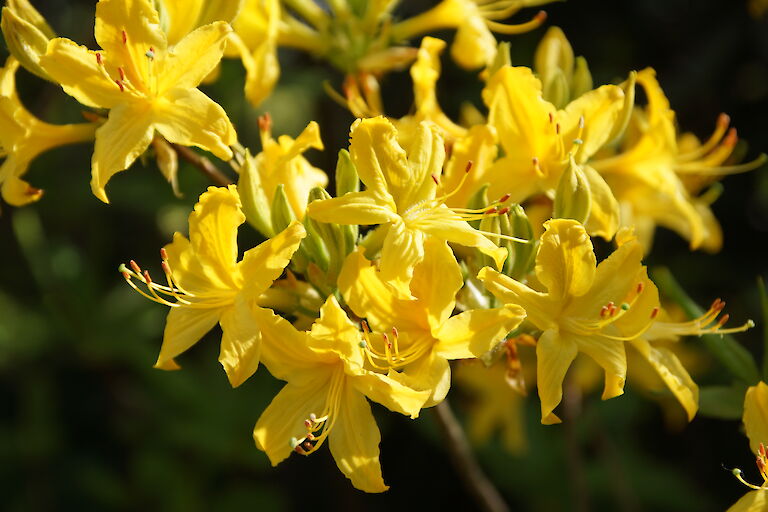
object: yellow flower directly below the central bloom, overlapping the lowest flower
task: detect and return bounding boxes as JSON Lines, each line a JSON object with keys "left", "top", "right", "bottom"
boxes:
{"left": 339, "top": 238, "right": 525, "bottom": 406}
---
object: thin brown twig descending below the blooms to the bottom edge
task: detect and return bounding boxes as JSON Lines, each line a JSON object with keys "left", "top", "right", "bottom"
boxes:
{"left": 432, "top": 399, "right": 509, "bottom": 512}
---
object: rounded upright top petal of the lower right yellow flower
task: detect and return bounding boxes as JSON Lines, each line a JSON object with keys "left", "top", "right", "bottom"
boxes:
{"left": 536, "top": 219, "right": 595, "bottom": 298}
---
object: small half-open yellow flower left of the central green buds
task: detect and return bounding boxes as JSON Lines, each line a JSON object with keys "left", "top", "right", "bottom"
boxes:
{"left": 254, "top": 116, "right": 328, "bottom": 220}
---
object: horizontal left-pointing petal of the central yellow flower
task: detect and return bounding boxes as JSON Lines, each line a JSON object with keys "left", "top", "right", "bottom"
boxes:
{"left": 307, "top": 190, "right": 399, "bottom": 225}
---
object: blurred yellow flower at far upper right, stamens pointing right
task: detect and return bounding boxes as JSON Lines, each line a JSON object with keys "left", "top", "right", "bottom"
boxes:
{"left": 592, "top": 68, "right": 764, "bottom": 252}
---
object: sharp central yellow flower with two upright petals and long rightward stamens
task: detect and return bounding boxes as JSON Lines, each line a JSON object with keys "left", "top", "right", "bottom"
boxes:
{"left": 307, "top": 117, "right": 507, "bottom": 296}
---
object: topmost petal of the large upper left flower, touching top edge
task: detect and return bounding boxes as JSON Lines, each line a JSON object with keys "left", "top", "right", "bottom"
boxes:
{"left": 94, "top": 0, "right": 168, "bottom": 84}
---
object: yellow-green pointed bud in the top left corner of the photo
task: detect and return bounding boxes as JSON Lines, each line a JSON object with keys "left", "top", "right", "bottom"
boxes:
{"left": 0, "top": 0, "right": 56, "bottom": 82}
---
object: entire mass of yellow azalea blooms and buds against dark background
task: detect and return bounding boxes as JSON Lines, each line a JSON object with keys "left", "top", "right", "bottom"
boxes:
{"left": 0, "top": 0, "right": 768, "bottom": 498}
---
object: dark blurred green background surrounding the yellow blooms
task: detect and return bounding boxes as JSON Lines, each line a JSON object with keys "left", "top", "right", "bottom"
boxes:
{"left": 0, "top": 0, "right": 768, "bottom": 511}
